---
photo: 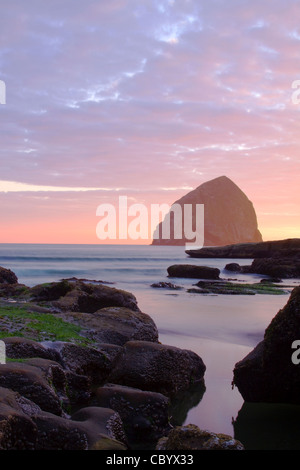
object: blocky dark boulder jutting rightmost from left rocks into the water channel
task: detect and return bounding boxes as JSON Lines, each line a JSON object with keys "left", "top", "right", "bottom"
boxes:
{"left": 108, "top": 341, "right": 206, "bottom": 397}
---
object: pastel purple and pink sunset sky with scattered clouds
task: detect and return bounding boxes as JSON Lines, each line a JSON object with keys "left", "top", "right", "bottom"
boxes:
{"left": 0, "top": 0, "right": 300, "bottom": 244}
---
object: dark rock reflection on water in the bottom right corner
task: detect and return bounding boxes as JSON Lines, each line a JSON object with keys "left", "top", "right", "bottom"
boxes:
{"left": 233, "top": 403, "right": 300, "bottom": 450}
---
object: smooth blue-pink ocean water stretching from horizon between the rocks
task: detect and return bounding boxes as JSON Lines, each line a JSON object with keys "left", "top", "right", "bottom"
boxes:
{"left": 0, "top": 244, "right": 300, "bottom": 450}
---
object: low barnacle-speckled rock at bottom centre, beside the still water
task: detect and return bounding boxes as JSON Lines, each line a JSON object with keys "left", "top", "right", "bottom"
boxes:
{"left": 156, "top": 424, "right": 244, "bottom": 451}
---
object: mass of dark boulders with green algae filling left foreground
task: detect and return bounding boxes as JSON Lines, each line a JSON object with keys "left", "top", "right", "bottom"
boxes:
{"left": 0, "top": 268, "right": 243, "bottom": 451}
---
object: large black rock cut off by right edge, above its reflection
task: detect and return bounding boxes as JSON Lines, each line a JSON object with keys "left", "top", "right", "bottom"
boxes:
{"left": 233, "top": 287, "right": 300, "bottom": 404}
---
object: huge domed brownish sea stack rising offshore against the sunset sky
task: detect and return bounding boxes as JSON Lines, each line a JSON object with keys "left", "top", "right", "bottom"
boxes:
{"left": 152, "top": 176, "right": 262, "bottom": 246}
